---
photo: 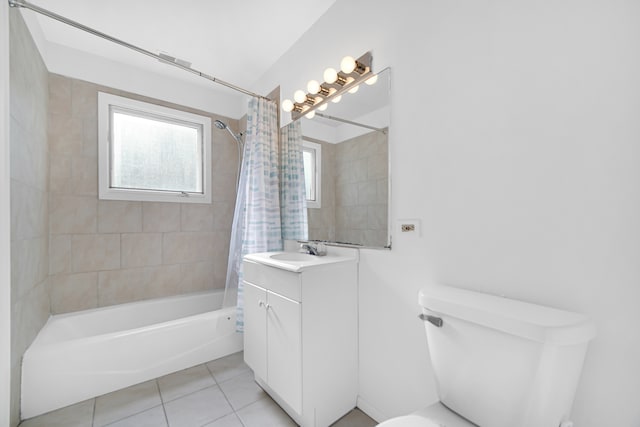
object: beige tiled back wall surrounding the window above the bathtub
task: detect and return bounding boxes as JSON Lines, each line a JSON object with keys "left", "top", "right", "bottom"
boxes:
{"left": 49, "top": 74, "right": 238, "bottom": 314}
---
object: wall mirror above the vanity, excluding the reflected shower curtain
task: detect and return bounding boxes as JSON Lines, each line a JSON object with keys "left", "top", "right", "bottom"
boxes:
{"left": 288, "top": 68, "right": 391, "bottom": 247}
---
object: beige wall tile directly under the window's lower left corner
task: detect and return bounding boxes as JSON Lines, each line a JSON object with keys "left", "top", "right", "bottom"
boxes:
{"left": 98, "top": 200, "right": 142, "bottom": 233}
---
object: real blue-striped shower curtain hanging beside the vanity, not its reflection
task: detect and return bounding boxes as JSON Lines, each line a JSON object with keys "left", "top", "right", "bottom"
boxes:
{"left": 224, "top": 98, "right": 282, "bottom": 331}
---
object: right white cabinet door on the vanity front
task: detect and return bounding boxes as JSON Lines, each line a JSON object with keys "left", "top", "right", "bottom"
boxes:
{"left": 268, "top": 291, "right": 302, "bottom": 413}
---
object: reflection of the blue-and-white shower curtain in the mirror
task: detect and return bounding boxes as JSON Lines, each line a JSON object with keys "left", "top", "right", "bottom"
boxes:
{"left": 280, "top": 120, "right": 309, "bottom": 240}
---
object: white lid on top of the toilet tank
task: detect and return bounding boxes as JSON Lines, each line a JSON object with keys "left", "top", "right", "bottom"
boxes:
{"left": 419, "top": 285, "right": 596, "bottom": 345}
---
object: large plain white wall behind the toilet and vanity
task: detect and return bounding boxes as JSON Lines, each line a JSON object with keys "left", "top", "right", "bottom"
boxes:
{"left": 253, "top": 0, "right": 640, "bottom": 427}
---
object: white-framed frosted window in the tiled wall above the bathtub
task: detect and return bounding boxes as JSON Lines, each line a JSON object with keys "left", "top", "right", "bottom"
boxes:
{"left": 98, "top": 92, "right": 211, "bottom": 203}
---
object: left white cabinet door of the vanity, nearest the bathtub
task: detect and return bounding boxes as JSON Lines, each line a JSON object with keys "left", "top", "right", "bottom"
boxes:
{"left": 243, "top": 282, "right": 267, "bottom": 381}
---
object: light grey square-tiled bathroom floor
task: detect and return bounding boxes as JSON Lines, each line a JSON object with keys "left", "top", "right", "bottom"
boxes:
{"left": 20, "top": 352, "right": 376, "bottom": 427}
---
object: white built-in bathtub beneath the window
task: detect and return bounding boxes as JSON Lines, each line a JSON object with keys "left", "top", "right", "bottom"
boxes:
{"left": 21, "top": 291, "right": 242, "bottom": 419}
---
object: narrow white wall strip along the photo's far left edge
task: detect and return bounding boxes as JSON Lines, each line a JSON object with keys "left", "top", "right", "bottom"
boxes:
{"left": 0, "top": 2, "right": 11, "bottom": 425}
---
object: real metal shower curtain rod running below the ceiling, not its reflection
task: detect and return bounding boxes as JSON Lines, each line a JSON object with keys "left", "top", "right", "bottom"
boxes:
{"left": 9, "top": 0, "right": 273, "bottom": 101}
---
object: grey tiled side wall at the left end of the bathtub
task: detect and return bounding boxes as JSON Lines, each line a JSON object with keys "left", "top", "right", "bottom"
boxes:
{"left": 9, "top": 9, "right": 49, "bottom": 426}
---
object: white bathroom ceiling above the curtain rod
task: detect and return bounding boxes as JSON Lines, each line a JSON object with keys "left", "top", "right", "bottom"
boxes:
{"left": 28, "top": 0, "right": 336, "bottom": 93}
